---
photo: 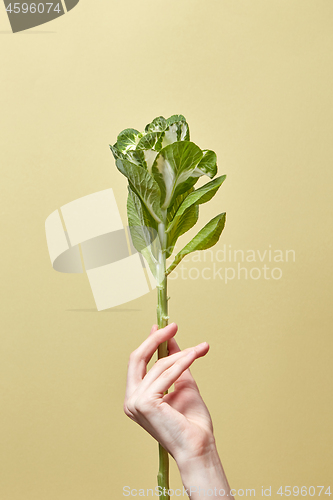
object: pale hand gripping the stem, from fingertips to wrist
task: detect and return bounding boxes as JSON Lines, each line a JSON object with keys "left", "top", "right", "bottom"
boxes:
{"left": 124, "top": 323, "right": 215, "bottom": 462}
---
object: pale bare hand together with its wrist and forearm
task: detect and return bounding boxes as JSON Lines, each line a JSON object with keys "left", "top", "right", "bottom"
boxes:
{"left": 124, "top": 324, "right": 232, "bottom": 500}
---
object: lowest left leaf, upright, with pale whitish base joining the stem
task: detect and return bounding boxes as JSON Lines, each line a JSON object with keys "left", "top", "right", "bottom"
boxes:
{"left": 127, "top": 187, "right": 163, "bottom": 283}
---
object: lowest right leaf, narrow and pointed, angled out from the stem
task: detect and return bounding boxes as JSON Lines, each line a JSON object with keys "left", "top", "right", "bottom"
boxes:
{"left": 166, "top": 213, "right": 226, "bottom": 275}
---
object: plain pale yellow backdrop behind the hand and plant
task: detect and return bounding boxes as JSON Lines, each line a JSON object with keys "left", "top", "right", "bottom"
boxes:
{"left": 0, "top": 0, "right": 333, "bottom": 500}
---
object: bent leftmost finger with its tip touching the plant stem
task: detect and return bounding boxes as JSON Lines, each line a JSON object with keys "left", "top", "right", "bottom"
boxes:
{"left": 126, "top": 323, "right": 178, "bottom": 394}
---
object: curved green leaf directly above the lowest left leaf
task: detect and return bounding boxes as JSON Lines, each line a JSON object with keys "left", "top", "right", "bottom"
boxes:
{"left": 116, "top": 158, "right": 163, "bottom": 223}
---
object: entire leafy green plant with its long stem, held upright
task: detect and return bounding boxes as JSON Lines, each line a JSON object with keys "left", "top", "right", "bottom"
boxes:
{"left": 110, "top": 115, "right": 226, "bottom": 499}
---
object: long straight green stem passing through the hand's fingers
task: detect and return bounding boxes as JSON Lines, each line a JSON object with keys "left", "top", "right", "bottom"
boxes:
{"left": 157, "top": 223, "right": 170, "bottom": 500}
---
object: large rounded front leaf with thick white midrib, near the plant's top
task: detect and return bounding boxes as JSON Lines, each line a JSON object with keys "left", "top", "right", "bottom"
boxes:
{"left": 151, "top": 141, "right": 205, "bottom": 209}
